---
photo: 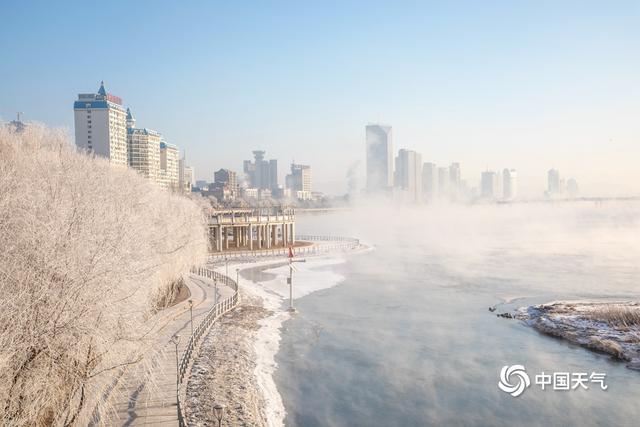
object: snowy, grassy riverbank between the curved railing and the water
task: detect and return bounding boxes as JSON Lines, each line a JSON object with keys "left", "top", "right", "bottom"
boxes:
{"left": 182, "top": 256, "right": 345, "bottom": 427}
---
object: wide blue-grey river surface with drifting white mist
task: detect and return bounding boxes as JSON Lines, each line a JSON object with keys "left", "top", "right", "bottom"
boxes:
{"left": 275, "top": 202, "right": 640, "bottom": 426}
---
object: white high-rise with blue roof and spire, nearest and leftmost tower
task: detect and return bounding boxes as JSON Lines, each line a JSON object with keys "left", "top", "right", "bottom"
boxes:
{"left": 73, "top": 82, "right": 128, "bottom": 166}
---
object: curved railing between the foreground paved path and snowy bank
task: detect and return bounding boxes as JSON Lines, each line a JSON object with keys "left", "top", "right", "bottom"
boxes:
{"left": 176, "top": 267, "right": 240, "bottom": 427}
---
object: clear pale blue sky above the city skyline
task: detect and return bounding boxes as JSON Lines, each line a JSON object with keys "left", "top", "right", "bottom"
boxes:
{"left": 0, "top": 0, "right": 640, "bottom": 194}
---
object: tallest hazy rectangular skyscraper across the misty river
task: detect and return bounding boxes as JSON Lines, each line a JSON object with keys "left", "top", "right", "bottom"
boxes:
{"left": 366, "top": 125, "right": 393, "bottom": 193}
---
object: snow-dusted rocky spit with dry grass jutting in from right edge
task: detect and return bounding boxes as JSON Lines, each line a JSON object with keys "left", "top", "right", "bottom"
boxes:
{"left": 508, "top": 301, "right": 640, "bottom": 370}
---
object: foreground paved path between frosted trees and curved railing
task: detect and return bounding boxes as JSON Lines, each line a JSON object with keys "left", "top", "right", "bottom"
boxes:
{"left": 105, "top": 274, "right": 233, "bottom": 426}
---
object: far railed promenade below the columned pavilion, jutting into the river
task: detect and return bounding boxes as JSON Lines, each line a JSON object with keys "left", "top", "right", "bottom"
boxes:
{"left": 209, "top": 234, "right": 360, "bottom": 261}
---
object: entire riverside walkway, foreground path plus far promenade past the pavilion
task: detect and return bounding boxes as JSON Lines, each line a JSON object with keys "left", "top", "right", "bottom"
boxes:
{"left": 96, "top": 236, "right": 362, "bottom": 426}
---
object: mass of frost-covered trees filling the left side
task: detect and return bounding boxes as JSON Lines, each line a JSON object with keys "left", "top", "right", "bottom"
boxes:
{"left": 0, "top": 125, "right": 207, "bottom": 425}
